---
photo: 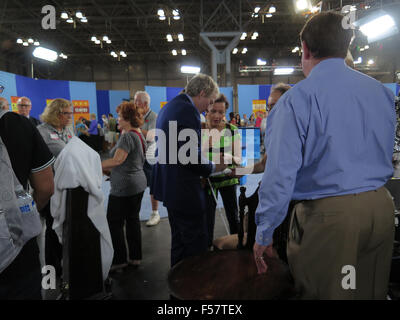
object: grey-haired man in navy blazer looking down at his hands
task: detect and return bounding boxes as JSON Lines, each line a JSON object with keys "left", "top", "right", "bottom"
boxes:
{"left": 151, "top": 74, "right": 226, "bottom": 266}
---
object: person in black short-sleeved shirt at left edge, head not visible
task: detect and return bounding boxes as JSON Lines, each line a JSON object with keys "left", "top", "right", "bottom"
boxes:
{"left": 0, "top": 112, "right": 55, "bottom": 300}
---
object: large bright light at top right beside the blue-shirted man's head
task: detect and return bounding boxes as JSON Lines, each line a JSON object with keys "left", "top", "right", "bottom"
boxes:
{"left": 355, "top": 14, "right": 398, "bottom": 43}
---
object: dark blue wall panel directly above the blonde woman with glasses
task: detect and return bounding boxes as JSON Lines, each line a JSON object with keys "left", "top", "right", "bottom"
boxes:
{"left": 15, "top": 75, "right": 71, "bottom": 119}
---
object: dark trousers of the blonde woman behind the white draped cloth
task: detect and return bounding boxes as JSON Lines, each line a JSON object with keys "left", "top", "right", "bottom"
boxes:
{"left": 40, "top": 202, "right": 63, "bottom": 277}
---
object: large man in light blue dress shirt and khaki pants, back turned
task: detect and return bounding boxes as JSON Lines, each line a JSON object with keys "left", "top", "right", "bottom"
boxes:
{"left": 254, "top": 12, "right": 396, "bottom": 299}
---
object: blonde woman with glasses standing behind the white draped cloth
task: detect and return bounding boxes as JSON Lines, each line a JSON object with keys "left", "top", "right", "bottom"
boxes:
{"left": 37, "top": 98, "right": 74, "bottom": 276}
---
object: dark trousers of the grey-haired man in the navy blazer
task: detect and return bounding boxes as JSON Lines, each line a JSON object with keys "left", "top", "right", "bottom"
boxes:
{"left": 167, "top": 208, "right": 208, "bottom": 267}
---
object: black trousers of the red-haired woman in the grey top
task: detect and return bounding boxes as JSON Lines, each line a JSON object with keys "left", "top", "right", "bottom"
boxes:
{"left": 107, "top": 192, "right": 144, "bottom": 264}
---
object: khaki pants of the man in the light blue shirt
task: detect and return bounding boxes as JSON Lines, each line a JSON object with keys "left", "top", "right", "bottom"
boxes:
{"left": 287, "top": 187, "right": 394, "bottom": 299}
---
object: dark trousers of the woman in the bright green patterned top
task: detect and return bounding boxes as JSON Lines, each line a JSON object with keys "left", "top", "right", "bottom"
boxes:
{"left": 205, "top": 185, "right": 239, "bottom": 246}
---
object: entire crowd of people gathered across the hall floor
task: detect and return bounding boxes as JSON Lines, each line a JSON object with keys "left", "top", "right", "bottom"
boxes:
{"left": 0, "top": 12, "right": 396, "bottom": 299}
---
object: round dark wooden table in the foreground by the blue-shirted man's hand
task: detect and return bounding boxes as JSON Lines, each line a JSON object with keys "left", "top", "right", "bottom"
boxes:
{"left": 168, "top": 250, "right": 294, "bottom": 300}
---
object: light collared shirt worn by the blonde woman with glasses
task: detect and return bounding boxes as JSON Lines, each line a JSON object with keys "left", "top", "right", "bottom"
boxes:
{"left": 37, "top": 123, "right": 74, "bottom": 157}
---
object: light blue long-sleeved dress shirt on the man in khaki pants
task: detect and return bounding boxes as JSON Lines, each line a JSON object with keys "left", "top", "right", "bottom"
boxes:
{"left": 256, "top": 58, "right": 396, "bottom": 245}
